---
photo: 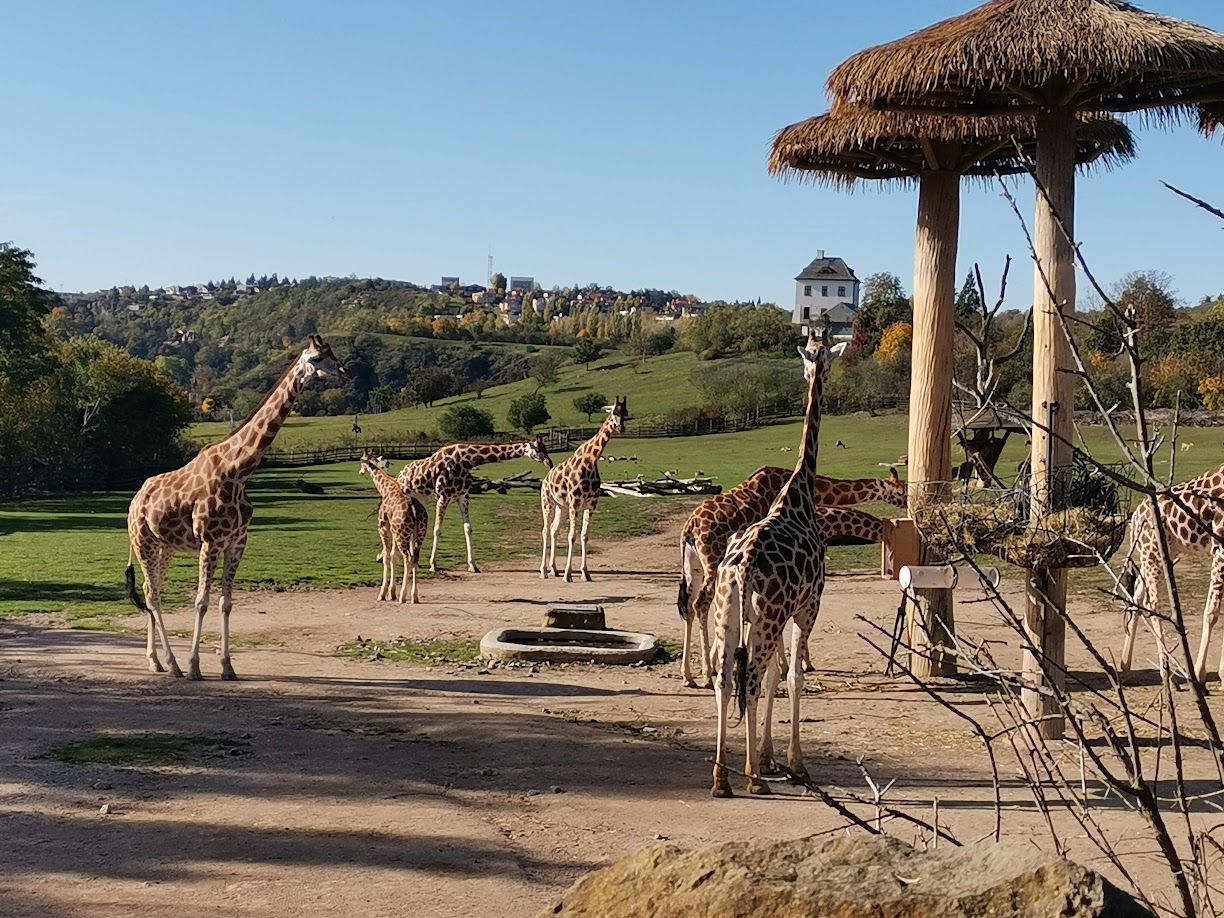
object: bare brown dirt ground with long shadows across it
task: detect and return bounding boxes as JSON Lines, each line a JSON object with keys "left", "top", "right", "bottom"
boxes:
{"left": 0, "top": 521, "right": 1219, "bottom": 918}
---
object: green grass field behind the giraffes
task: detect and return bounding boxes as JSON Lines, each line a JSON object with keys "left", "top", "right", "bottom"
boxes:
{"left": 0, "top": 396, "right": 1222, "bottom": 627}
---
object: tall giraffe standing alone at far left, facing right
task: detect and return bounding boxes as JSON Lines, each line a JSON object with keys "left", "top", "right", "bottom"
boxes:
{"left": 126, "top": 334, "right": 351, "bottom": 681}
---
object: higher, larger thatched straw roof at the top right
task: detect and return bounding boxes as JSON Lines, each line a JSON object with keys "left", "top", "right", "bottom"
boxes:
{"left": 827, "top": 0, "right": 1224, "bottom": 115}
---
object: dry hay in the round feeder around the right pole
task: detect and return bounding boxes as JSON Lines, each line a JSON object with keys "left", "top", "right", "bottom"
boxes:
{"left": 998, "top": 507, "right": 1126, "bottom": 570}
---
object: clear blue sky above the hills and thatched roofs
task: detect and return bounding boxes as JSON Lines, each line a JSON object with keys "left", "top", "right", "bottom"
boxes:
{"left": 7, "top": 0, "right": 1224, "bottom": 306}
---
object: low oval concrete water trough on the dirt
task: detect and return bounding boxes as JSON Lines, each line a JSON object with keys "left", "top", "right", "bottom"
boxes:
{"left": 480, "top": 628, "right": 659, "bottom": 663}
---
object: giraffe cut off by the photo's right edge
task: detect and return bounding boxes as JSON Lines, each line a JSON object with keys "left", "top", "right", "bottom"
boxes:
{"left": 1120, "top": 466, "right": 1224, "bottom": 682}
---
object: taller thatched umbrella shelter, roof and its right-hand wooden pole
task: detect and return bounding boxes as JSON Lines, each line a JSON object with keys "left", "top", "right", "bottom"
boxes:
{"left": 827, "top": 0, "right": 1224, "bottom": 737}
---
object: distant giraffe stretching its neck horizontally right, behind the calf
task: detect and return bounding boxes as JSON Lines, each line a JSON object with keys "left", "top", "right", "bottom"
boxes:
{"left": 398, "top": 437, "right": 552, "bottom": 574}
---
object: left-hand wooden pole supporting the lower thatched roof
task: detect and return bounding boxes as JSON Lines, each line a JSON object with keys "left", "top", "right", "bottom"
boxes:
{"left": 907, "top": 165, "right": 961, "bottom": 678}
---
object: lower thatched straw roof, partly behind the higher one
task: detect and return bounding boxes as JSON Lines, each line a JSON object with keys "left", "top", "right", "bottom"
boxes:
{"left": 769, "top": 105, "right": 1135, "bottom": 187}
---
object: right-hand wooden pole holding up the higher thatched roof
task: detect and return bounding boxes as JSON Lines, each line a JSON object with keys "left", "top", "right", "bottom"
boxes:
{"left": 1023, "top": 109, "right": 1076, "bottom": 739}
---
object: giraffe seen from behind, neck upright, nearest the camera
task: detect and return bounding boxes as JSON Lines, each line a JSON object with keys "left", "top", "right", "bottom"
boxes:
{"left": 710, "top": 329, "right": 846, "bottom": 797}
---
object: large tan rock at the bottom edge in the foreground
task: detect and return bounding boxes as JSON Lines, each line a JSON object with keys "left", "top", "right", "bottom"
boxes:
{"left": 540, "top": 835, "right": 1151, "bottom": 918}
